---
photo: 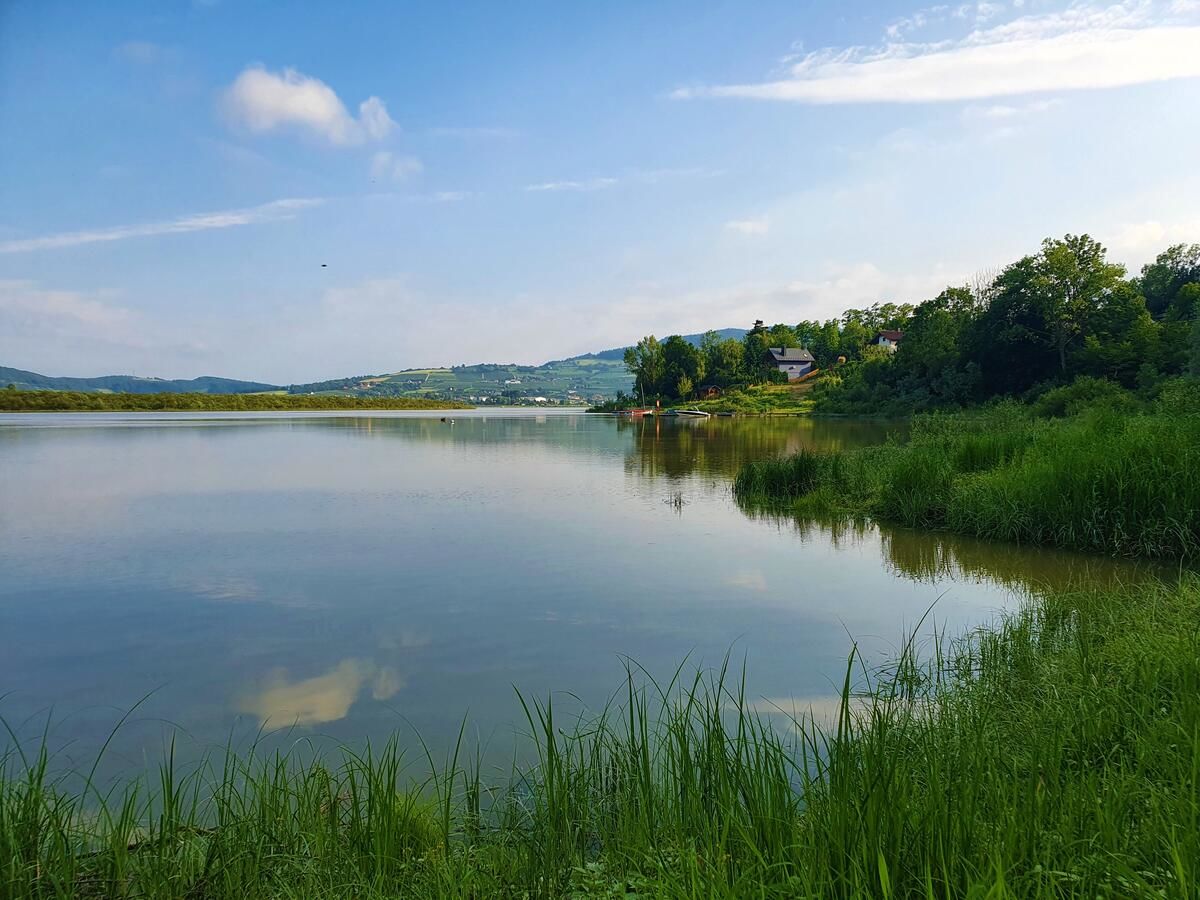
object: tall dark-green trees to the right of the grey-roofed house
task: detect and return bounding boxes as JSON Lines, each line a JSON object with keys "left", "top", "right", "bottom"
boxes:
{"left": 814, "top": 234, "right": 1200, "bottom": 413}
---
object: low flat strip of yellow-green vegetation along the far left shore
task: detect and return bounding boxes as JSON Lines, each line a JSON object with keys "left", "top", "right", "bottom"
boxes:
{"left": 0, "top": 390, "right": 469, "bottom": 413}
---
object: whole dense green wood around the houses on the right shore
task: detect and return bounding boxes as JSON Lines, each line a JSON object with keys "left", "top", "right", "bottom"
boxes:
{"left": 625, "top": 234, "right": 1200, "bottom": 414}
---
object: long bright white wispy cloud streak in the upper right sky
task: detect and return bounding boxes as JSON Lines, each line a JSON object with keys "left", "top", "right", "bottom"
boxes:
{"left": 672, "top": 0, "right": 1200, "bottom": 103}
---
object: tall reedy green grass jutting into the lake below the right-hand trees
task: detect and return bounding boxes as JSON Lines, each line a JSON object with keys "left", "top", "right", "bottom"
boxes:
{"left": 734, "top": 404, "right": 1200, "bottom": 558}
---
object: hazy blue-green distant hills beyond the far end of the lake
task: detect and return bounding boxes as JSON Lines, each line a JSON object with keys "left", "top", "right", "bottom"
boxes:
{"left": 7, "top": 328, "right": 746, "bottom": 403}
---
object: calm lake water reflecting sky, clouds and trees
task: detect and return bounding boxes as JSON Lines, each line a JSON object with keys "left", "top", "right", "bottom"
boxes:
{"left": 0, "top": 410, "right": 1161, "bottom": 766}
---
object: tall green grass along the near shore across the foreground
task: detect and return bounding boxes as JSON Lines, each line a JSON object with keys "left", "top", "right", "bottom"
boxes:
{"left": 0, "top": 580, "right": 1200, "bottom": 898}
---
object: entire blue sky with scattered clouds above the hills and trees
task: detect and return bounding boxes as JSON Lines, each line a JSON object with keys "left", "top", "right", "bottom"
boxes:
{"left": 0, "top": 0, "right": 1200, "bottom": 383}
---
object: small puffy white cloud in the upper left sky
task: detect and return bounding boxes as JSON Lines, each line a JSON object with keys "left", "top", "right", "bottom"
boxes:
{"left": 222, "top": 66, "right": 396, "bottom": 146}
